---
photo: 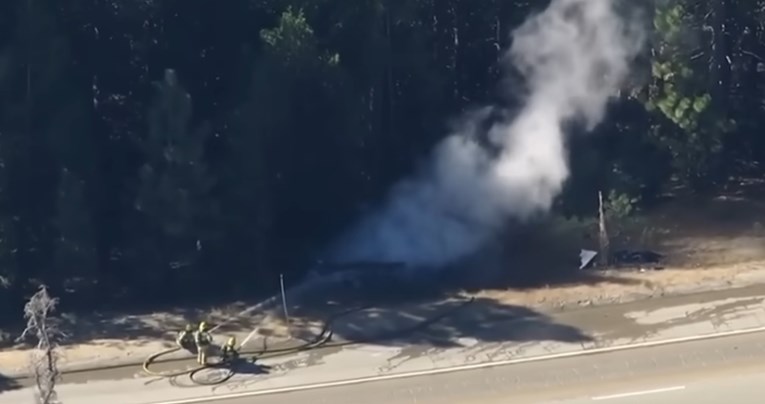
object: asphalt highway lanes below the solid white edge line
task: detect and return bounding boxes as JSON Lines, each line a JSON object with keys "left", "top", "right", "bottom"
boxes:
{"left": 152, "top": 333, "right": 765, "bottom": 404}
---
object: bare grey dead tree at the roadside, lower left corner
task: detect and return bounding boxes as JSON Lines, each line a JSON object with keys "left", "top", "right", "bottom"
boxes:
{"left": 19, "top": 285, "right": 63, "bottom": 404}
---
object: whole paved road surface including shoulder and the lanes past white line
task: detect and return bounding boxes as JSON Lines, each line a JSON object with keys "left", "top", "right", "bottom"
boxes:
{"left": 0, "top": 287, "right": 765, "bottom": 404}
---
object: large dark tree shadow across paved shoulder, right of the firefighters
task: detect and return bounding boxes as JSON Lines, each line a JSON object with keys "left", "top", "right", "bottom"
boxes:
{"left": 286, "top": 296, "right": 592, "bottom": 348}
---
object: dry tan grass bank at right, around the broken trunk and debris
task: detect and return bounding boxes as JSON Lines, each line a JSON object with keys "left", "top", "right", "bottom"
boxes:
{"left": 468, "top": 185, "right": 765, "bottom": 306}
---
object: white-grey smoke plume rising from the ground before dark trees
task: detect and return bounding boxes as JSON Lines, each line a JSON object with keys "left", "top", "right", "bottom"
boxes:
{"left": 334, "top": 0, "right": 644, "bottom": 267}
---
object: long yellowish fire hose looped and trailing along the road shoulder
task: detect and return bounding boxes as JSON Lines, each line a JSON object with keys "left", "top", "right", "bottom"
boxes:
{"left": 143, "top": 297, "right": 475, "bottom": 386}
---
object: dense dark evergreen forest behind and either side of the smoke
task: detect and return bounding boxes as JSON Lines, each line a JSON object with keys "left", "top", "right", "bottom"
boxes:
{"left": 0, "top": 0, "right": 765, "bottom": 314}
